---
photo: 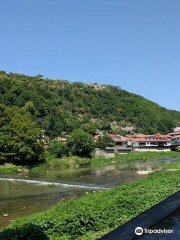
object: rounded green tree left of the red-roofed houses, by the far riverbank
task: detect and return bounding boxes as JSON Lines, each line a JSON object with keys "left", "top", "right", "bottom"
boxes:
{"left": 67, "top": 129, "right": 94, "bottom": 156}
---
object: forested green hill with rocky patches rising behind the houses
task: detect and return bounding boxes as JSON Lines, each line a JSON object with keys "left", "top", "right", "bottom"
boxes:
{"left": 0, "top": 71, "right": 180, "bottom": 138}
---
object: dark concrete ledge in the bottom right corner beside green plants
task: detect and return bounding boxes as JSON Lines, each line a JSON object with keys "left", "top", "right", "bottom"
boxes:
{"left": 101, "top": 191, "right": 180, "bottom": 240}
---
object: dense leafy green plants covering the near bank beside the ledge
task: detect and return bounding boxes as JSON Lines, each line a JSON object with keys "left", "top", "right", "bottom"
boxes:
{"left": 0, "top": 171, "right": 180, "bottom": 240}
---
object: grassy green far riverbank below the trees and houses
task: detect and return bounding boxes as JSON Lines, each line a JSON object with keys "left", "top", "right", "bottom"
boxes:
{"left": 0, "top": 152, "right": 180, "bottom": 174}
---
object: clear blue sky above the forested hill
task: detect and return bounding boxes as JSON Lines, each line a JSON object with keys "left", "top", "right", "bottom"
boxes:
{"left": 0, "top": 0, "right": 180, "bottom": 110}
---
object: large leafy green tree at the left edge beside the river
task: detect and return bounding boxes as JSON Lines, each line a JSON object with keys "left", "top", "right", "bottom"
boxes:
{"left": 0, "top": 104, "right": 44, "bottom": 161}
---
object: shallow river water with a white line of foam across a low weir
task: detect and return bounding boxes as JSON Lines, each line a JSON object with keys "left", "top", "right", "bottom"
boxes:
{"left": 0, "top": 158, "right": 180, "bottom": 229}
